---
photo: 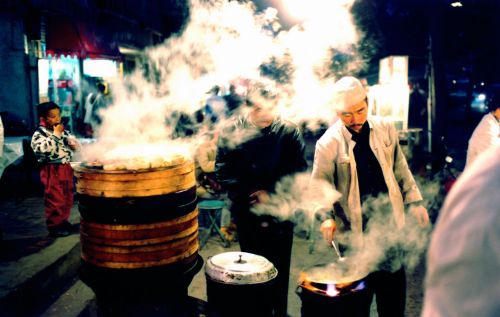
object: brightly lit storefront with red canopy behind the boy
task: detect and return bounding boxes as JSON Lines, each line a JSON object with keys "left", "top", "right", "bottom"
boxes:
{"left": 38, "top": 15, "right": 123, "bottom": 136}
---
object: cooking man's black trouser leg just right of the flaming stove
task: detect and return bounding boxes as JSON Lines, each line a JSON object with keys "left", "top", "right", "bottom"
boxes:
{"left": 366, "top": 267, "right": 406, "bottom": 317}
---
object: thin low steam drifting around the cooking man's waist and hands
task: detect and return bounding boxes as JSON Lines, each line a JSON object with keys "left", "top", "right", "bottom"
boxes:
{"left": 252, "top": 173, "right": 438, "bottom": 276}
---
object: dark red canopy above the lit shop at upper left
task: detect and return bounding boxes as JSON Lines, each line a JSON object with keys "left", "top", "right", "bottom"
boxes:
{"left": 45, "top": 15, "right": 121, "bottom": 59}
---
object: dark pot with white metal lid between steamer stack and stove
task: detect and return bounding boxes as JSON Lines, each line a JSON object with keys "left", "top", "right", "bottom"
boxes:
{"left": 205, "top": 252, "right": 278, "bottom": 316}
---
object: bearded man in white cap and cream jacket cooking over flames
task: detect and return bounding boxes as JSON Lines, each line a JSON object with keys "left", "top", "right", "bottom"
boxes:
{"left": 312, "top": 77, "right": 429, "bottom": 317}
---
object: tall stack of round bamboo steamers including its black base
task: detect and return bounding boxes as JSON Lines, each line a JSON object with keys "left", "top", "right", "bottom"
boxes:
{"left": 74, "top": 160, "right": 203, "bottom": 315}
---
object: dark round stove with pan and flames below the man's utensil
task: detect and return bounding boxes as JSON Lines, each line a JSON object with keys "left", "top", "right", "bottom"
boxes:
{"left": 296, "top": 258, "right": 371, "bottom": 317}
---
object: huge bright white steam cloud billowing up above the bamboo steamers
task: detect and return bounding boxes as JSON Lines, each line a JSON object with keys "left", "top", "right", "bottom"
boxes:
{"left": 82, "top": 0, "right": 362, "bottom": 161}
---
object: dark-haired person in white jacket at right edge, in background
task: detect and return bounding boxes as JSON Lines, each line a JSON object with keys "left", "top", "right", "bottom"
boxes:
{"left": 465, "top": 93, "right": 500, "bottom": 168}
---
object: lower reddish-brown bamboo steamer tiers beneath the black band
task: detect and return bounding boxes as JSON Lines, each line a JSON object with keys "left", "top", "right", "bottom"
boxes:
{"left": 80, "top": 209, "right": 198, "bottom": 269}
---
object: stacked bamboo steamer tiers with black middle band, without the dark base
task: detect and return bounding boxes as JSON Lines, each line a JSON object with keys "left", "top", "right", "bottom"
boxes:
{"left": 74, "top": 160, "right": 199, "bottom": 273}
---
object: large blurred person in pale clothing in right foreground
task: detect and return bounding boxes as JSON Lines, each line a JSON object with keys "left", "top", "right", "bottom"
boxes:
{"left": 422, "top": 147, "right": 500, "bottom": 317}
